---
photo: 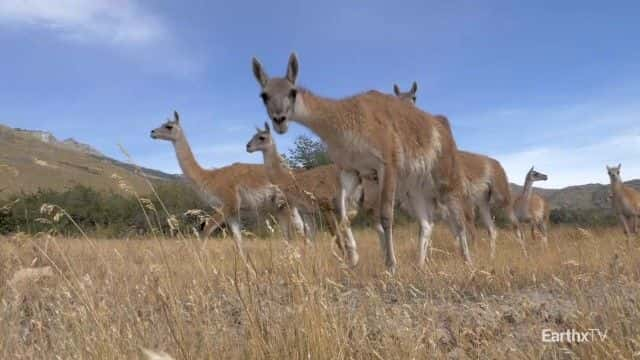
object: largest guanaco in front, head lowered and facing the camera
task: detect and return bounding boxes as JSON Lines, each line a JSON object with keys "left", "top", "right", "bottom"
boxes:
{"left": 253, "top": 54, "right": 471, "bottom": 272}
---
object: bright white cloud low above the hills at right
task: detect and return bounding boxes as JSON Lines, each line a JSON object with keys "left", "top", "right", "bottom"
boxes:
{"left": 495, "top": 131, "right": 640, "bottom": 188}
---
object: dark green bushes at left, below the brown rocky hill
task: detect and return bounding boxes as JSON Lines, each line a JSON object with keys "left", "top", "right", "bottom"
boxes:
{"left": 0, "top": 183, "right": 206, "bottom": 237}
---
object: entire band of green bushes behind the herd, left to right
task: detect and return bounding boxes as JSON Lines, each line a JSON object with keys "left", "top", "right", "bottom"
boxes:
{"left": 0, "top": 182, "right": 617, "bottom": 237}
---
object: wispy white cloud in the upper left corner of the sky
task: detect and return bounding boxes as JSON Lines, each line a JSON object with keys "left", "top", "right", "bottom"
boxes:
{"left": 0, "top": 0, "right": 203, "bottom": 76}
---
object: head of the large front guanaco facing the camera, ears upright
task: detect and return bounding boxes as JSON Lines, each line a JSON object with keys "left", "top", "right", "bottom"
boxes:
{"left": 253, "top": 53, "right": 298, "bottom": 134}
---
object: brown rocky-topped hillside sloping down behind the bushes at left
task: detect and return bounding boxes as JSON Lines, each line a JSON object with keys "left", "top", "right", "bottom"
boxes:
{"left": 0, "top": 125, "right": 181, "bottom": 196}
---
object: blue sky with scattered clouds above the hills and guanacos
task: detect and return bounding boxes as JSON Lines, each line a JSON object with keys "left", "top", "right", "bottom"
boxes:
{"left": 0, "top": 0, "right": 640, "bottom": 187}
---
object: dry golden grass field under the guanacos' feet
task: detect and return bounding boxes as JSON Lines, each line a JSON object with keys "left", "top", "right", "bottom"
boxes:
{"left": 0, "top": 226, "right": 640, "bottom": 359}
